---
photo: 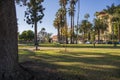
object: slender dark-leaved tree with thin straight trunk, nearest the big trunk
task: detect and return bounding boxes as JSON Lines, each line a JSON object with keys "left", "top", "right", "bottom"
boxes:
{"left": 25, "top": 0, "right": 45, "bottom": 50}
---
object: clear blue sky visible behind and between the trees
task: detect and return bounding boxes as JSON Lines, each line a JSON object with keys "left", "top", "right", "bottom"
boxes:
{"left": 16, "top": 0, "right": 120, "bottom": 35}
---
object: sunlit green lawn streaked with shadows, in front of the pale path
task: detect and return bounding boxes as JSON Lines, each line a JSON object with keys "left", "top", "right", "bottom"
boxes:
{"left": 19, "top": 48, "right": 120, "bottom": 80}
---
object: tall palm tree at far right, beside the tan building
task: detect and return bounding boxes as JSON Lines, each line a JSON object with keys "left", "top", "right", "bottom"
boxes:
{"left": 103, "top": 4, "right": 120, "bottom": 41}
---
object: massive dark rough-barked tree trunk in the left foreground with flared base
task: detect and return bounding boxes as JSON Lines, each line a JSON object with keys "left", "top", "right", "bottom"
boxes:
{"left": 0, "top": 0, "right": 31, "bottom": 80}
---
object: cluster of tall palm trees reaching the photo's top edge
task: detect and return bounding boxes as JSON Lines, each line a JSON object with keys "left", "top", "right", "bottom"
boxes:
{"left": 53, "top": 0, "right": 77, "bottom": 43}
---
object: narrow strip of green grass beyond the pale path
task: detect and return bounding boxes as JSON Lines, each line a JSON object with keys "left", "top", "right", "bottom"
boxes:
{"left": 19, "top": 43, "right": 120, "bottom": 48}
